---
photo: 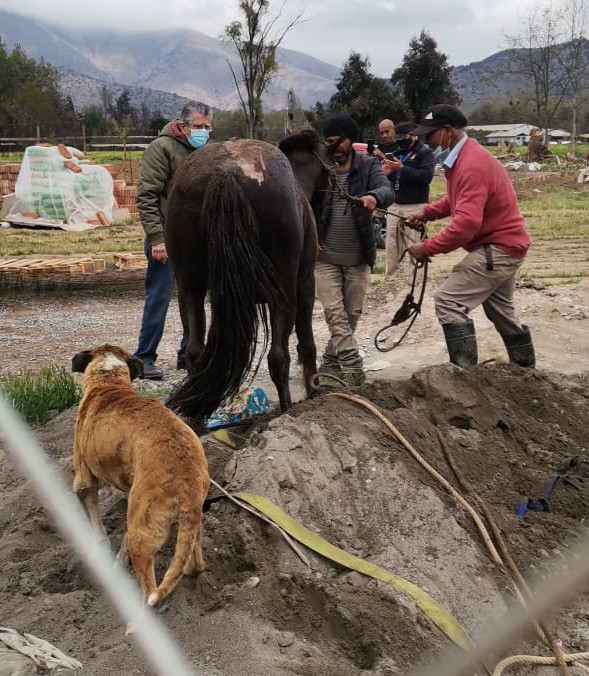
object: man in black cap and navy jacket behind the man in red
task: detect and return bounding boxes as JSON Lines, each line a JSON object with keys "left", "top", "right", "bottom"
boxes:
{"left": 381, "top": 122, "right": 436, "bottom": 278}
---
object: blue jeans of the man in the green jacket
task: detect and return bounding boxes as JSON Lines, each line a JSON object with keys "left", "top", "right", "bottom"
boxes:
{"left": 134, "top": 239, "right": 187, "bottom": 364}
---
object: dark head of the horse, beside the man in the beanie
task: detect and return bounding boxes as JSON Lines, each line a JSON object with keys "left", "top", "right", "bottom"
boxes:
{"left": 278, "top": 129, "right": 331, "bottom": 202}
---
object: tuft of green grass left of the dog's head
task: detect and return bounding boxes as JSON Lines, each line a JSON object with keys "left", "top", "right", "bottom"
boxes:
{"left": 0, "top": 366, "right": 82, "bottom": 423}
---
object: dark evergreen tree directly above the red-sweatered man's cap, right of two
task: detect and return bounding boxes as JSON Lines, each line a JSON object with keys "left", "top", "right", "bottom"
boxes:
{"left": 391, "top": 30, "right": 460, "bottom": 120}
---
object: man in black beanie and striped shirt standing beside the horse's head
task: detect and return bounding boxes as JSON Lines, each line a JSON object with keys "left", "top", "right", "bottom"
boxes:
{"left": 315, "top": 115, "right": 393, "bottom": 385}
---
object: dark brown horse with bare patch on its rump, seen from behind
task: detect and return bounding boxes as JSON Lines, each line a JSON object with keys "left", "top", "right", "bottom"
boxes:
{"left": 165, "top": 130, "right": 329, "bottom": 424}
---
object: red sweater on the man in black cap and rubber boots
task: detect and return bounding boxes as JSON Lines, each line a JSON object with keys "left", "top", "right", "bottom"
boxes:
{"left": 423, "top": 138, "right": 530, "bottom": 258}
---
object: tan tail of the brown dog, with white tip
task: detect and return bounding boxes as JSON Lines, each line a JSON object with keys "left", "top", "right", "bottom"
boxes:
{"left": 147, "top": 505, "right": 204, "bottom": 606}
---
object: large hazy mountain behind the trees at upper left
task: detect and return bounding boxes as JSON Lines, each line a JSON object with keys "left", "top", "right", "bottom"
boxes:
{"left": 0, "top": 10, "right": 340, "bottom": 115}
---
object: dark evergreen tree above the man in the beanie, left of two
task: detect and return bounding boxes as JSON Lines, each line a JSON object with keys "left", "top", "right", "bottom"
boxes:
{"left": 308, "top": 52, "right": 406, "bottom": 138}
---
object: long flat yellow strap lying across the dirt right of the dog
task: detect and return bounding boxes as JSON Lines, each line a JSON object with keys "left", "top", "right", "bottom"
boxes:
{"left": 232, "top": 493, "right": 470, "bottom": 650}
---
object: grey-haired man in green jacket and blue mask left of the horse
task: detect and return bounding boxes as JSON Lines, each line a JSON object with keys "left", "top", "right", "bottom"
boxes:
{"left": 135, "top": 101, "right": 212, "bottom": 380}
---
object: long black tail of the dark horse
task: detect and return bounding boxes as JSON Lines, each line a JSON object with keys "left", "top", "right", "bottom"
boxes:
{"left": 167, "top": 170, "right": 284, "bottom": 420}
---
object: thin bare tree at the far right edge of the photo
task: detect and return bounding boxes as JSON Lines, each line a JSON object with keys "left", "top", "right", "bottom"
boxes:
{"left": 561, "top": 0, "right": 589, "bottom": 153}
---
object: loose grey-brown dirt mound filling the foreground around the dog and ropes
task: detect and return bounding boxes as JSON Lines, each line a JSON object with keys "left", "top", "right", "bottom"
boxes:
{"left": 0, "top": 365, "right": 589, "bottom": 676}
